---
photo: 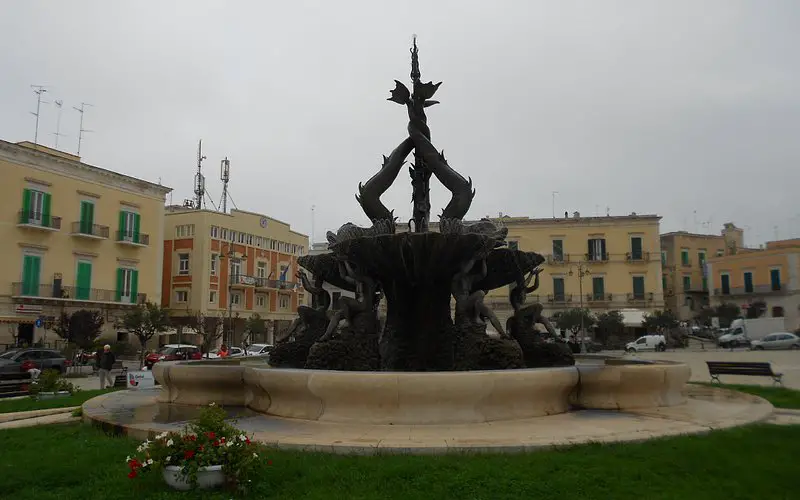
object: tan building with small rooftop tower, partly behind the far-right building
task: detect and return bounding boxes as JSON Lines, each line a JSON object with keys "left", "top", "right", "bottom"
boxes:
{"left": 661, "top": 223, "right": 746, "bottom": 321}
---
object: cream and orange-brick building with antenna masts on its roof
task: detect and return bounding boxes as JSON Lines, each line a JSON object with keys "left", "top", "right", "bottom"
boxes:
{"left": 161, "top": 206, "right": 308, "bottom": 345}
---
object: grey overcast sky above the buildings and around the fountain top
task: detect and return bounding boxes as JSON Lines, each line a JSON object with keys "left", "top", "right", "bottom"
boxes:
{"left": 0, "top": 0, "right": 800, "bottom": 245}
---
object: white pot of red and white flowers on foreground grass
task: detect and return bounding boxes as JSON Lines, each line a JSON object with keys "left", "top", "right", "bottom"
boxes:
{"left": 126, "top": 403, "right": 258, "bottom": 491}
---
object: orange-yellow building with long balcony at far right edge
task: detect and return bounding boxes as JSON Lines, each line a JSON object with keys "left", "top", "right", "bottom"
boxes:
{"left": 708, "top": 239, "right": 800, "bottom": 331}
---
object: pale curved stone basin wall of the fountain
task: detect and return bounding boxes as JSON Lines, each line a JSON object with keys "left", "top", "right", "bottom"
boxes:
{"left": 153, "top": 358, "right": 691, "bottom": 425}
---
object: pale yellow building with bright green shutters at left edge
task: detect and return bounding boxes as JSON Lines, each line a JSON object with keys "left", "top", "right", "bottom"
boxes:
{"left": 0, "top": 141, "right": 171, "bottom": 344}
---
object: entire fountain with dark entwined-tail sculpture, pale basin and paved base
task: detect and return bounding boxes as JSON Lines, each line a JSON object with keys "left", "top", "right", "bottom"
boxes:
{"left": 84, "top": 40, "right": 772, "bottom": 452}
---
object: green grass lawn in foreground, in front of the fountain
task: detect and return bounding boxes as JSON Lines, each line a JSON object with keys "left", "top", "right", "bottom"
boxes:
{"left": 0, "top": 424, "right": 800, "bottom": 500}
